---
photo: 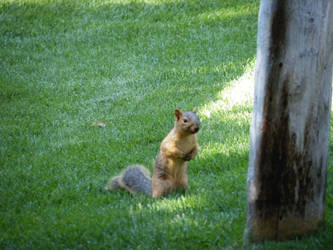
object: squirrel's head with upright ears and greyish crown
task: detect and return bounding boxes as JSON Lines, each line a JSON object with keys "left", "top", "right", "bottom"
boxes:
{"left": 175, "top": 109, "right": 200, "bottom": 134}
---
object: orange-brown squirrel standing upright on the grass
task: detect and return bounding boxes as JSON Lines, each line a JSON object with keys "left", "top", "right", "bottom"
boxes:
{"left": 105, "top": 109, "right": 200, "bottom": 198}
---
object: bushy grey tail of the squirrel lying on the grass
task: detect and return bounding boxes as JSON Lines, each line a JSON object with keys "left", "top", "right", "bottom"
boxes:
{"left": 105, "top": 165, "right": 152, "bottom": 195}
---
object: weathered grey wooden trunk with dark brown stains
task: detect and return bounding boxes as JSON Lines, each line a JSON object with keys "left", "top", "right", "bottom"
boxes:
{"left": 245, "top": 0, "right": 333, "bottom": 242}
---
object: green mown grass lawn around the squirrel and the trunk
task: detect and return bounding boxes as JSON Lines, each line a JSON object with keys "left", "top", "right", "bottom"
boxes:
{"left": 0, "top": 0, "right": 333, "bottom": 250}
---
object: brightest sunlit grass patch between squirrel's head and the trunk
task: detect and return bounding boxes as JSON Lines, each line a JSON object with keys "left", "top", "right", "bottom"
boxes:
{"left": 199, "top": 63, "right": 254, "bottom": 118}
